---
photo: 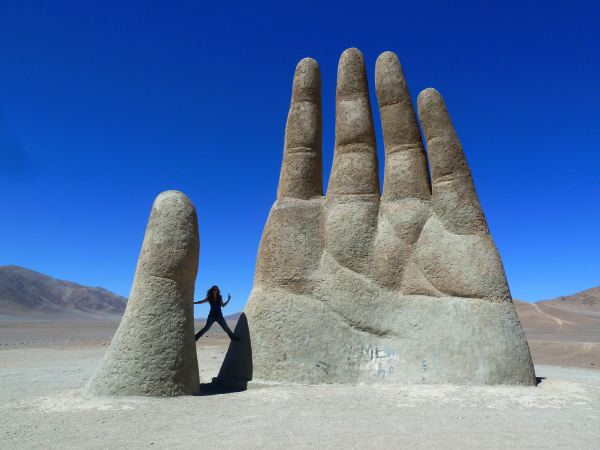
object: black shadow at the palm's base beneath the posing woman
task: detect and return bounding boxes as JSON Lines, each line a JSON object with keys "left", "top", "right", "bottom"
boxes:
{"left": 198, "top": 313, "right": 252, "bottom": 396}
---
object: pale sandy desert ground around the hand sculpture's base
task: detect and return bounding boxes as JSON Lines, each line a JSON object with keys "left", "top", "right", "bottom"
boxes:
{"left": 0, "top": 320, "right": 600, "bottom": 449}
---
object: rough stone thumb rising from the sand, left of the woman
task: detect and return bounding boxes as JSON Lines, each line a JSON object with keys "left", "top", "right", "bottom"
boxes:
{"left": 85, "top": 191, "right": 200, "bottom": 396}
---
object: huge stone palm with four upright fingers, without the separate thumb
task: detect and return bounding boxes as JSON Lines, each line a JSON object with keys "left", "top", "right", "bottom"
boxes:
{"left": 232, "top": 49, "right": 535, "bottom": 385}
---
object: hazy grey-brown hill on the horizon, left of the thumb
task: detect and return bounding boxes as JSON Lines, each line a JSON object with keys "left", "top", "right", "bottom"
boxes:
{"left": 0, "top": 266, "right": 127, "bottom": 317}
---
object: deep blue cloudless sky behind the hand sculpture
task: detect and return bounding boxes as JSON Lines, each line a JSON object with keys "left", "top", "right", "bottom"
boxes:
{"left": 0, "top": 0, "right": 600, "bottom": 315}
